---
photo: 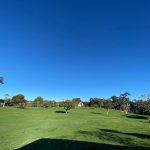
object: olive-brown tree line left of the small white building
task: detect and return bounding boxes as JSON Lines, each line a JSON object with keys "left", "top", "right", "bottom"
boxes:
{"left": 0, "top": 94, "right": 81, "bottom": 108}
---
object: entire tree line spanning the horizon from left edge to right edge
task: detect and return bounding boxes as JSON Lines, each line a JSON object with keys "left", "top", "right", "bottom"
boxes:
{"left": 0, "top": 77, "right": 150, "bottom": 115}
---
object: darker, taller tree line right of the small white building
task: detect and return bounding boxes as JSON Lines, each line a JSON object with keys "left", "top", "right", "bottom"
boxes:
{"left": 86, "top": 92, "right": 150, "bottom": 115}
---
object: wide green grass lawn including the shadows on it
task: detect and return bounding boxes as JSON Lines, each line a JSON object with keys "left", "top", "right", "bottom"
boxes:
{"left": 0, "top": 108, "right": 150, "bottom": 150}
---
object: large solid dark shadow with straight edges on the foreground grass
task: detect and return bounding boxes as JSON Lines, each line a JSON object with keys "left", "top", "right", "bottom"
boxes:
{"left": 17, "top": 138, "right": 148, "bottom": 150}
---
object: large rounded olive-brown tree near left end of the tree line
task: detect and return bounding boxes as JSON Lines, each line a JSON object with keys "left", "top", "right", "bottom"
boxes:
{"left": 11, "top": 94, "right": 26, "bottom": 108}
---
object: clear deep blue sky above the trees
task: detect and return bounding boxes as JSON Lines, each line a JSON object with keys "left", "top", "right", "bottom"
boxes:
{"left": 0, "top": 0, "right": 150, "bottom": 100}
